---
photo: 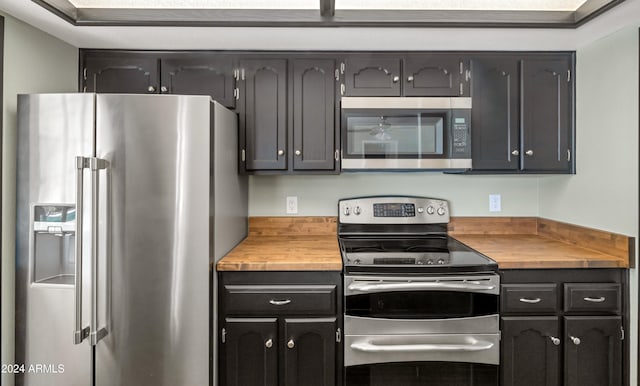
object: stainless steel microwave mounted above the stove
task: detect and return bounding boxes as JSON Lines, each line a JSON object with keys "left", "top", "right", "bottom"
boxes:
{"left": 341, "top": 97, "right": 471, "bottom": 170}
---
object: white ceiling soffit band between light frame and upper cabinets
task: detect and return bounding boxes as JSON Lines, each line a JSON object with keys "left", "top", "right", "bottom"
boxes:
{"left": 0, "top": 0, "right": 640, "bottom": 50}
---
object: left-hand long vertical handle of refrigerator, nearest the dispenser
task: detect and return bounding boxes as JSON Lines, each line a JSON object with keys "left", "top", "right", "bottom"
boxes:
{"left": 73, "top": 156, "right": 89, "bottom": 344}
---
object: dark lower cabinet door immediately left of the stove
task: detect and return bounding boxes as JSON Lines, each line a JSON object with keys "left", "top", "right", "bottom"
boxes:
{"left": 283, "top": 318, "right": 336, "bottom": 386}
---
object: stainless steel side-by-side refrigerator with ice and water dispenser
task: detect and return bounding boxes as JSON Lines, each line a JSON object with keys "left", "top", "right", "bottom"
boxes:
{"left": 16, "top": 93, "right": 247, "bottom": 386}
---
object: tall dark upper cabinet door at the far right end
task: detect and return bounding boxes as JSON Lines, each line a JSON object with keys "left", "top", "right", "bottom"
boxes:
{"left": 520, "top": 56, "right": 573, "bottom": 172}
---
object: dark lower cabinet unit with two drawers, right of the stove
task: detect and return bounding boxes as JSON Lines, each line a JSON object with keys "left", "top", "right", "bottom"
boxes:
{"left": 500, "top": 269, "right": 629, "bottom": 386}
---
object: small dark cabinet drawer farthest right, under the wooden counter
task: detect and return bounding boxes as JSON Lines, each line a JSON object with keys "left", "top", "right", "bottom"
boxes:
{"left": 564, "top": 283, "right": 621, "bottom": 314}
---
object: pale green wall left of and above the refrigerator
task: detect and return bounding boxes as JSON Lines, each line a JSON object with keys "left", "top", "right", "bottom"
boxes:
{"left": 0, "top": 13, "right": 78, "bottom": 386}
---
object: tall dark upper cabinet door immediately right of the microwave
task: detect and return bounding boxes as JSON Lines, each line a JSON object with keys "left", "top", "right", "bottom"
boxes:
{"left": 471, "top": 57, "right": 520, "bottom": 170}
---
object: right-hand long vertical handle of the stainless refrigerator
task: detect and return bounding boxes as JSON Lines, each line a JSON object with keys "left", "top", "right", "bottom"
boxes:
{"left": 89, "top": 157, "right": 109, "bottom": 346}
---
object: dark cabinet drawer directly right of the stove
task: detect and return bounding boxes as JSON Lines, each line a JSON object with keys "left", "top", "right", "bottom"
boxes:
{"left": 500, "top": 283, "right": 558, "bottom": 314}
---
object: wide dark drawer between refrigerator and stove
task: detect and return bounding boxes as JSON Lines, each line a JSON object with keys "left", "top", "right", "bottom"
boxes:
{"left": 222, "top": 285, "right": 336, "bottom": 315}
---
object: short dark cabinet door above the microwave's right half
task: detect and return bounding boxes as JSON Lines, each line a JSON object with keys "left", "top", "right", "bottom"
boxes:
{"left": 403, "top": 54, "right": 469, "bottom": 96}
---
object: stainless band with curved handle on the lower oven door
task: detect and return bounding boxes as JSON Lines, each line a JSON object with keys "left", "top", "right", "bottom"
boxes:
{"left": 344, "top": 333, "right": 500, "bottom": 366}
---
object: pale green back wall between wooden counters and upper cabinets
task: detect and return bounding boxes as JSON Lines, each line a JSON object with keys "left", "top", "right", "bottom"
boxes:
{"left": 249, "top": 173, "right": 540, "bottom": 216}
